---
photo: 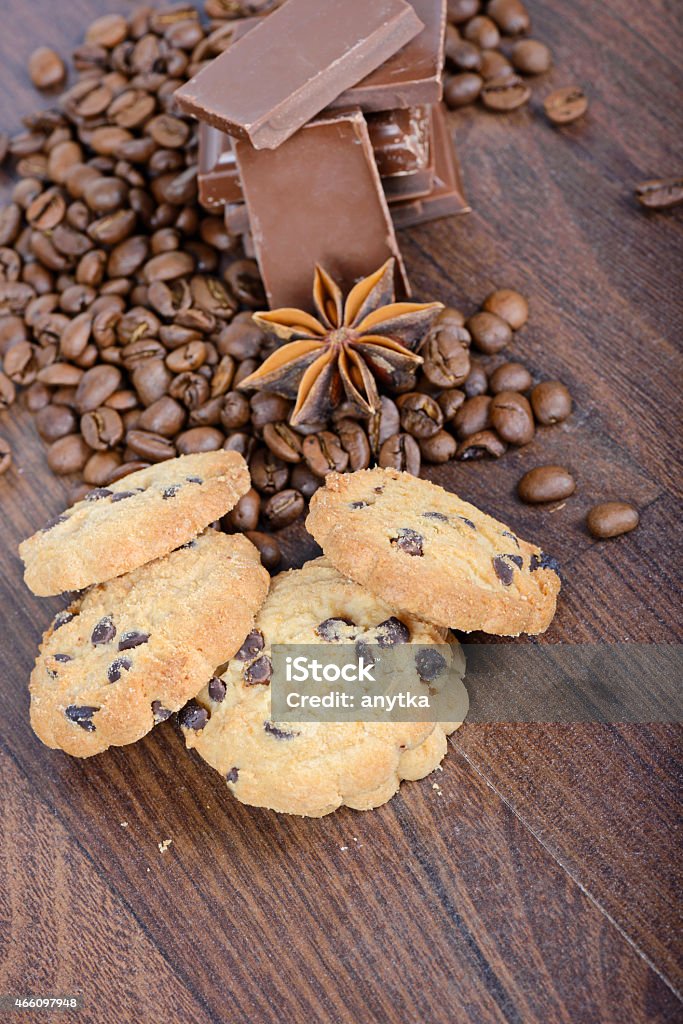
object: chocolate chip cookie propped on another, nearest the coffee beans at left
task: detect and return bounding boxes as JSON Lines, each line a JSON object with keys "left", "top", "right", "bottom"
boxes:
{"left": 19, "top": 451, "right": 250, "bottom": 597}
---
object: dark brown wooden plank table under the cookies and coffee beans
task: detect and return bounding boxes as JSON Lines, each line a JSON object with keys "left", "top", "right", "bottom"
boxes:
{"left": 0, "top": 0, "right": 683, "bottom": 1024}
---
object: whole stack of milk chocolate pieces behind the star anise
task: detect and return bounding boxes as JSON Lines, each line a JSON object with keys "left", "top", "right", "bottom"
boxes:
{"left": 176, "top": 0, "right": 468, "bottom": 309}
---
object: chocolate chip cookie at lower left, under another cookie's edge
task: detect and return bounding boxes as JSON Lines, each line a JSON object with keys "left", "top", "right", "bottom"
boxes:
{"left": 30, "top": 529, "right": 268, "bottom": 758}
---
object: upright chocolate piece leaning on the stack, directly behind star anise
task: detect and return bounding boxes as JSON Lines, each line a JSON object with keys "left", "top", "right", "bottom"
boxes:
{"left": 234, "top": 111, "right": 409, "bottom": 309}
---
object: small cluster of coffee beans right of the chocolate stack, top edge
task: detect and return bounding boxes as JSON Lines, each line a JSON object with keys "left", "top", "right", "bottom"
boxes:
{"left": 443, "top": 0, "right": 588, "bottom": 125}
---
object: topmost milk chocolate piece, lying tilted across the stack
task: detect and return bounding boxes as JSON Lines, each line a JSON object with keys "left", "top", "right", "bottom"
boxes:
{"left": 175, "top": 0, "right": 424, "bottom": 150}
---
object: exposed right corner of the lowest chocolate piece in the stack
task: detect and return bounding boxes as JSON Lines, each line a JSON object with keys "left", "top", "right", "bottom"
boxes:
{"left": 390, "top": 103, "right": 470, "bottom": 227}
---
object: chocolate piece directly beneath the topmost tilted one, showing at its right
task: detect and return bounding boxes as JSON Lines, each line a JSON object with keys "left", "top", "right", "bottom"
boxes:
{"left": 330, "top": 0, "right": 446, "bottom": 113}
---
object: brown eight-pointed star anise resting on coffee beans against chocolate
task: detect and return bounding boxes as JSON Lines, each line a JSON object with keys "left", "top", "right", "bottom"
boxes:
{"left": 240, "top": 259, "right": 443, "bottom": 426}
